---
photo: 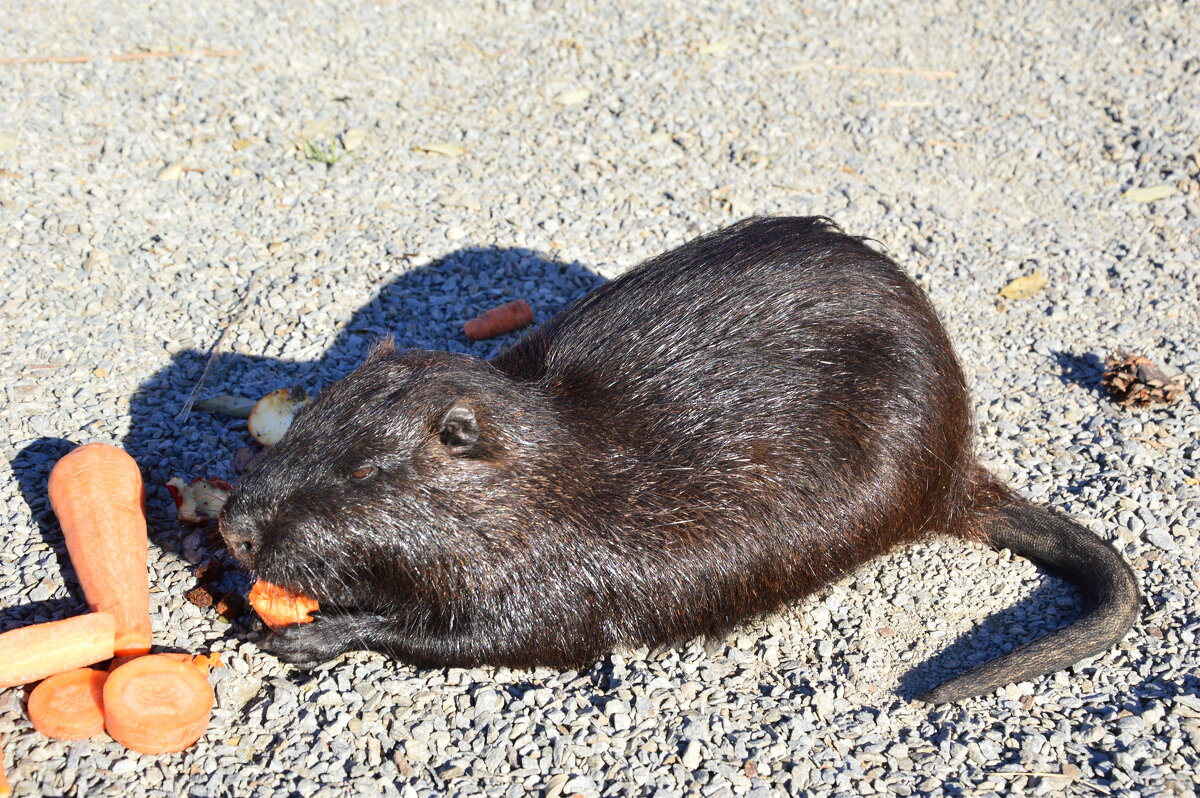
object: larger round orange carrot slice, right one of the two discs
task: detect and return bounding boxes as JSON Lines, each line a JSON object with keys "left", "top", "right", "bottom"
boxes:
{"left": 104, "top": 654, "right": 212, "bottom": 754}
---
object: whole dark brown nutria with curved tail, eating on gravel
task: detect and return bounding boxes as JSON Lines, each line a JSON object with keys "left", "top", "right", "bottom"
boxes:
{"left": 222, "top": 218, "right": 1139, "bottom": 701}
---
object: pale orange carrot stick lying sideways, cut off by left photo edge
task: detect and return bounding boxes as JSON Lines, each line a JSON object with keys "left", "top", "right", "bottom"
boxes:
{"left": 0, "top": 612, "right": 116, "bottom": 688}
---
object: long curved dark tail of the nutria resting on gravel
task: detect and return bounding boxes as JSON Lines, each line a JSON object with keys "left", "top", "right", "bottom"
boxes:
{"left": 919, "top": 493, "right": 1141, "bottom": 703}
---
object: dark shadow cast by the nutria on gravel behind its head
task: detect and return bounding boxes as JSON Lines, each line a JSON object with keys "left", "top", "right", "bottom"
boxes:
{"left": 124, "top": 242, "right": 604, "bottom": 499}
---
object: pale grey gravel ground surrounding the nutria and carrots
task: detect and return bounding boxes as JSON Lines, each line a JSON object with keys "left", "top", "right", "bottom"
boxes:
{"left": 0, "top": 0, "right": 1200, "bottom": 797}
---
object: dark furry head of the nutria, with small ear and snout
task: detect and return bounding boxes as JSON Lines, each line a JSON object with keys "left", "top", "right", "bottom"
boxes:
{"left": 220, "top": 341, "right": 545, "bottom": 611}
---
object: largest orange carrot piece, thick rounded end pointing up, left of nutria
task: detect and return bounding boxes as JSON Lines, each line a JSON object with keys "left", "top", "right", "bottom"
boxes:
{"left": 49, "top": 443, "right": 150, "bottom": 654}
